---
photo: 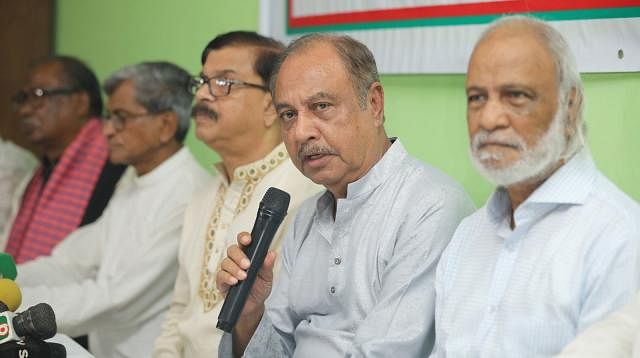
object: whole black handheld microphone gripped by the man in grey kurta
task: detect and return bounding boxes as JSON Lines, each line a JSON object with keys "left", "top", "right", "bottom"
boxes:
{"left": 216, "top": 187, "right": 291, "bottom": 333}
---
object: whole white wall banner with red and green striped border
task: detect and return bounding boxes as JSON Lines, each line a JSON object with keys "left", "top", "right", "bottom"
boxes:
{"left": 261, "top": 0, "right": 640, "bottom": 73}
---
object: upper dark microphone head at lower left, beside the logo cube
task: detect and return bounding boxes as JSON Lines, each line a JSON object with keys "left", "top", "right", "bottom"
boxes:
{"left": 13, "top": 303, "right": 58, "bottom": 339}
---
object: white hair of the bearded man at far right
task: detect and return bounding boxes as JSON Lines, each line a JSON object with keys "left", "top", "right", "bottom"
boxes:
{"left": 476, "top": 15, "right": 587, "bottom": 155}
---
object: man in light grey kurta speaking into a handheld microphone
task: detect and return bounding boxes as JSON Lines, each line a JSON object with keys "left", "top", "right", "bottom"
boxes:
{"left": 217, "top": 34, "right": 473, "bottom": 357}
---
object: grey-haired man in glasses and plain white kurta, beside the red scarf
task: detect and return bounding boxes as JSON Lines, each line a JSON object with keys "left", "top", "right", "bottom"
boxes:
{"left": 18, "top": 62, "right": 208, "bottom": 357}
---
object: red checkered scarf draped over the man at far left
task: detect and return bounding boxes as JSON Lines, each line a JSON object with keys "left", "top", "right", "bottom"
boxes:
{"left": 6, "top": 119, "right": 109, "bottom": 263}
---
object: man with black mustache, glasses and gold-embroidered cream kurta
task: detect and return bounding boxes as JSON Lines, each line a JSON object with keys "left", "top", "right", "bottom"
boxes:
{"left": 154, "top": 31, "right": 320, "bottom": 357}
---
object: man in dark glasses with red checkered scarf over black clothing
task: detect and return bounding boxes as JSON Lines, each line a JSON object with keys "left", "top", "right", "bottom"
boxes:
{"left": 0, "top": 56, "right": 125, "bottom": 263}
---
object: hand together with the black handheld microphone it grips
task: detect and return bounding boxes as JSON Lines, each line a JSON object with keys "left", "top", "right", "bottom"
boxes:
{"left": 216, "top": 188, "right": 290, "bottom": 332}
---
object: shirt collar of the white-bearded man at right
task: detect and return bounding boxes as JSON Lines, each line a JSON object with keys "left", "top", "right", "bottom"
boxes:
{"left": 487, "top": 147, "right": 597, "bottom": 221}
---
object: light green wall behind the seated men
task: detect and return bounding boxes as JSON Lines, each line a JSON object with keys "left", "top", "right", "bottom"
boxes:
{"left": 55, "top": 0, "right": 640, "bottom": 205}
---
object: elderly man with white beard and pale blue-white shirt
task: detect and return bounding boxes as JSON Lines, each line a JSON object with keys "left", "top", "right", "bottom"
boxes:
{"left": 432, "top": 16, "right": 640, "bottom": 357}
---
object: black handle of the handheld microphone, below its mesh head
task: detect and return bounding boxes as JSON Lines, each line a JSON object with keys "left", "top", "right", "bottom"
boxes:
{"left": 216, "top": 208, "right": 284, "bottom": 333}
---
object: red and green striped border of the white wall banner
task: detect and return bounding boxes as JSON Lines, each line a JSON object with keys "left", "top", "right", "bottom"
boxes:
{"left": 287, "top": 0, "right": 640, "bottom": 34}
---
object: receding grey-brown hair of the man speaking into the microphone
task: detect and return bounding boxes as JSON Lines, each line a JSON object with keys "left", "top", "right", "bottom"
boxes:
{"left": 269, "top": 33, "right": 380, "bottom": 110}
